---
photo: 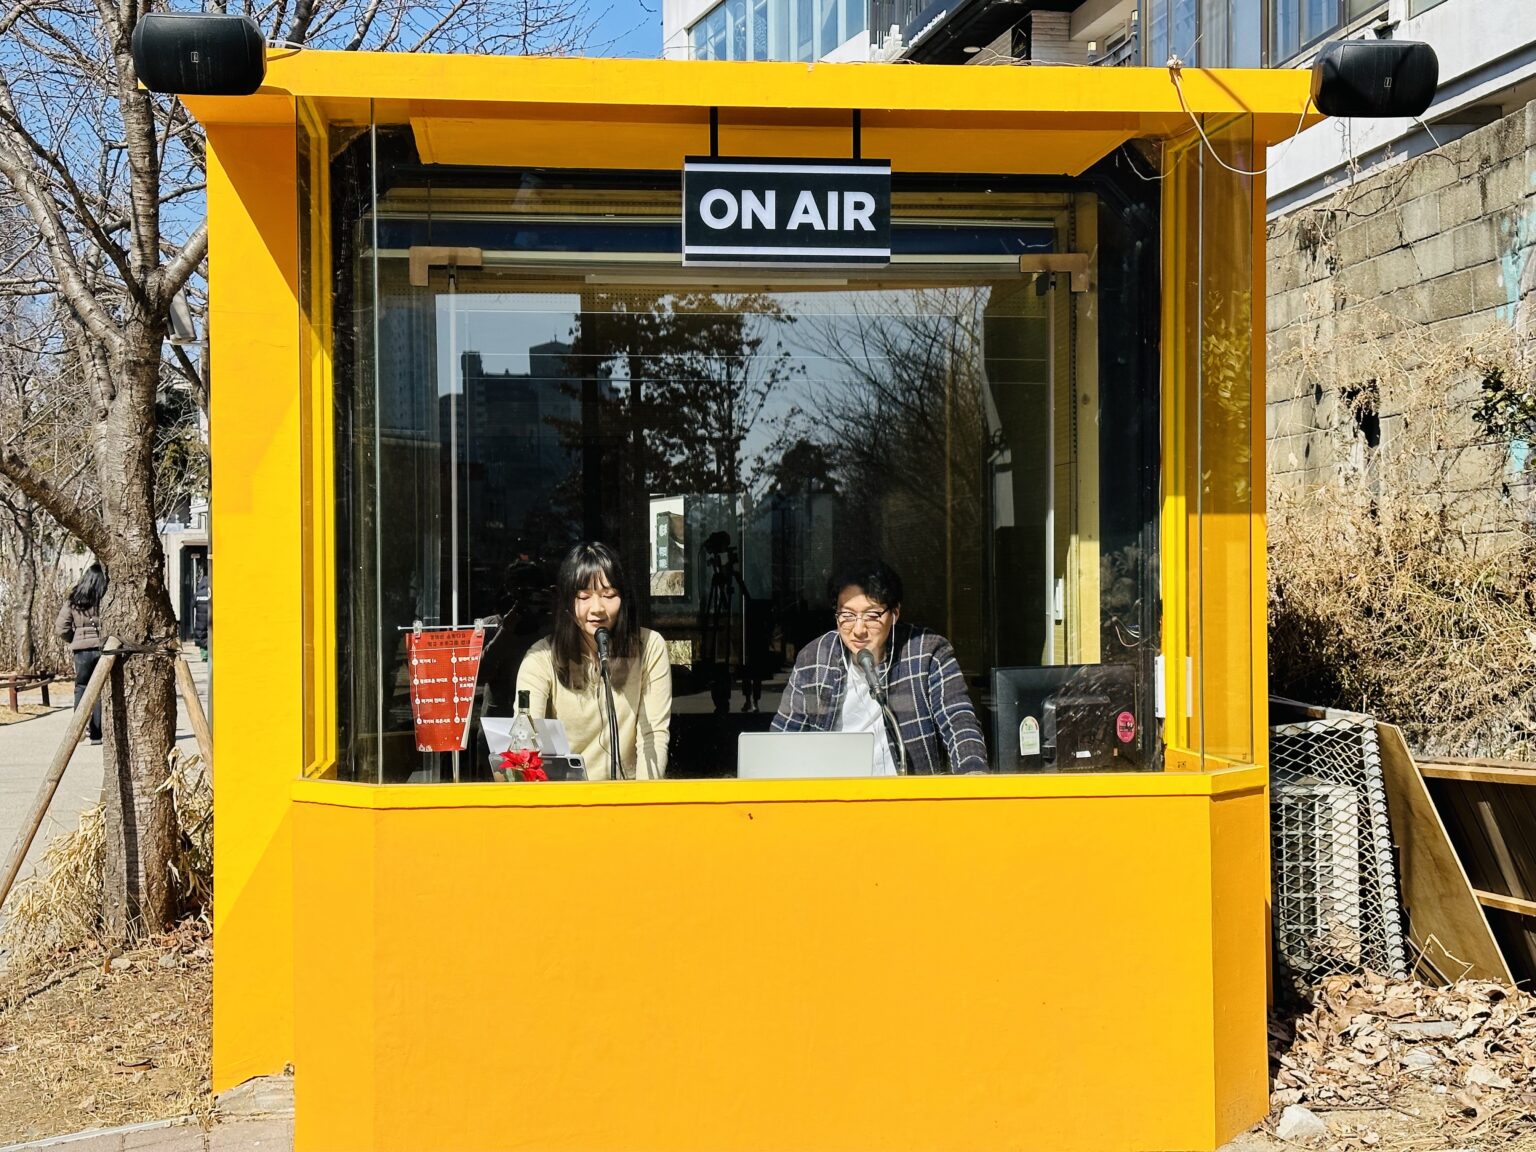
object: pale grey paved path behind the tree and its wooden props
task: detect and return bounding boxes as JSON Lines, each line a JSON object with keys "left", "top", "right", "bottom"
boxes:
{"left": 0, "top": 648, "right": 209, "bottom": 940}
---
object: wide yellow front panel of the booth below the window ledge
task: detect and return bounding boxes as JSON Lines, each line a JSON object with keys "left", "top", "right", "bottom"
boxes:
{"left": 288, "top": 782, "right": 1264, "bottom": 1152}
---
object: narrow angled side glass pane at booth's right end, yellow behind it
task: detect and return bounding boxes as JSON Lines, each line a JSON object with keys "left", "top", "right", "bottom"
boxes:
{"left": 1163, "top": 117, "right": 1264, "bottom": 763}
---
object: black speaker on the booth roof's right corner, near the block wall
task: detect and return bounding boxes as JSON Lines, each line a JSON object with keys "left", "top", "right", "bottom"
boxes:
{"left": 1312, "top": 40, "right": 1439, "bottom": 117}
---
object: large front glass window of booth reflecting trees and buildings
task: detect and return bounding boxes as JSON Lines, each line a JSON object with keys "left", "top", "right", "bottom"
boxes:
{"left": 332, "top": 129, "right": 1160, "bottom": 782}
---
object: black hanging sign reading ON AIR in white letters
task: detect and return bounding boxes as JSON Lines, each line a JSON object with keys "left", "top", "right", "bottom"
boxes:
{"left": 682, "top": 160, "right": 891, "bottom": 264}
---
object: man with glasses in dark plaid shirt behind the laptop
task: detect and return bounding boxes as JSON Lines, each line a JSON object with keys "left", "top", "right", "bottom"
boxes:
{"left": 773, "top": 561, "right": 989, "bottom": 776}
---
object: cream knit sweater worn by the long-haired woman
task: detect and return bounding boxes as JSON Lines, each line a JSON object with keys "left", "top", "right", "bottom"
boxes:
{"left": 518, "top": 628, "right": 671, "bottom": 780}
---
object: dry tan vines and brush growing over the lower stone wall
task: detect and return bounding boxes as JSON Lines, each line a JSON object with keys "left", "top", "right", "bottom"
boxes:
{"left": 1269, "top": 306, "right": 1536, "bottom": 759}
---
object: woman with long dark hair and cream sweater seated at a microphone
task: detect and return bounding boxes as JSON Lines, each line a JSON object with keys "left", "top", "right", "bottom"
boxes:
{"left": 518, "top": 542, "right": 671, "bottom": 780}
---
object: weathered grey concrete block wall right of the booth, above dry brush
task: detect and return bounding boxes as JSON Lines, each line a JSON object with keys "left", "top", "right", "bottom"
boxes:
{"left": 1266, "top": 104, "right": 1536, "bottom": 535}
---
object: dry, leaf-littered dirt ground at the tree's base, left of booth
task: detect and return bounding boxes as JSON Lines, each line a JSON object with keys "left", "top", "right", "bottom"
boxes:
{"left": 0, "top": 922, "right": 214, "bottom": 1144}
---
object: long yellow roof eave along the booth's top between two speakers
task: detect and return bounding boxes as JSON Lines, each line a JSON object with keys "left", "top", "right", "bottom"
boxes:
{"left": 183, "top": 49, "right": 1322, "bottom": 146}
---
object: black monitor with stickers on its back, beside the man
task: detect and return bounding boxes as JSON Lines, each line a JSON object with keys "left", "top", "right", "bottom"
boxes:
{"left": 992, "top": 664, "right": 1157, "bottom": 773}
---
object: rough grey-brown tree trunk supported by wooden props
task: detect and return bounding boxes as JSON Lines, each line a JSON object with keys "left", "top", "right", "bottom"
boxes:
{"left": 98, "top": 327, "right": 177, "bottom": 943}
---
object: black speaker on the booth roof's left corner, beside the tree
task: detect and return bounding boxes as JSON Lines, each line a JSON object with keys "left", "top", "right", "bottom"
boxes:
{"left": 134, "top": 12, "right": 267, "bottom": 95}
